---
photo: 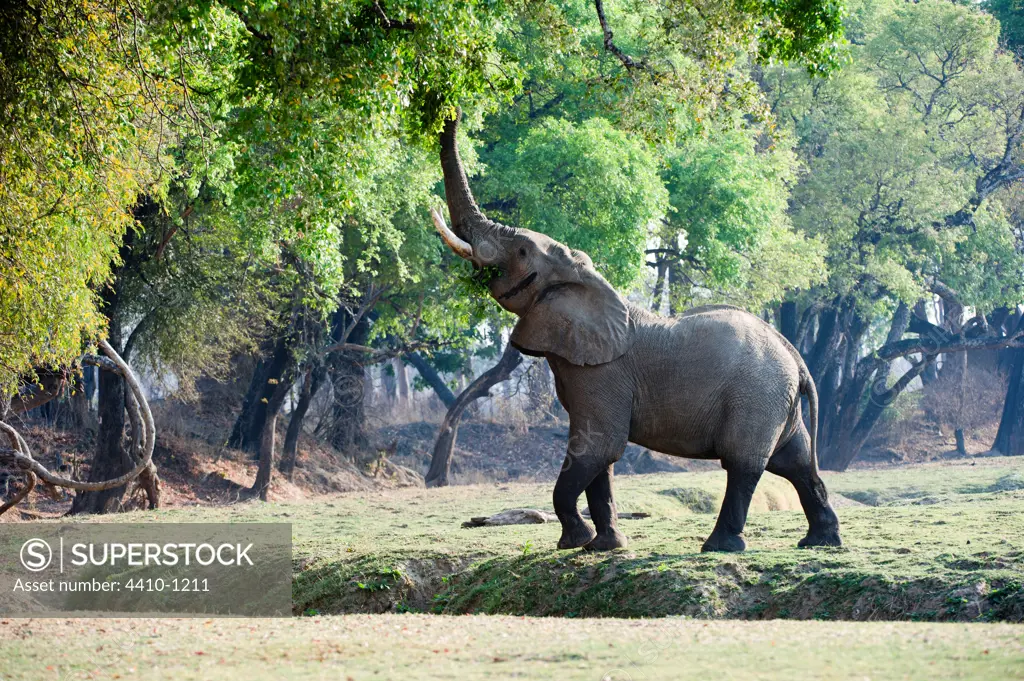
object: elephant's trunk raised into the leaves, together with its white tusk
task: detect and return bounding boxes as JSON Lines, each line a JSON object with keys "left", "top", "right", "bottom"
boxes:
{"left": 434, "top": 112, "right": 516, "bottom": 265}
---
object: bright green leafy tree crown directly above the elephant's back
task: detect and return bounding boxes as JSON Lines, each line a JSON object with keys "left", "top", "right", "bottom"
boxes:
{"left": 657, "top": 126, "right": 824, "bottom": 310}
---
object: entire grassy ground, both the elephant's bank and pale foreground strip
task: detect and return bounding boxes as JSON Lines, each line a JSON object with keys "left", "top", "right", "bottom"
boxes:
{"left": 0, "top": 459, "right": 1024, "bottom": 681}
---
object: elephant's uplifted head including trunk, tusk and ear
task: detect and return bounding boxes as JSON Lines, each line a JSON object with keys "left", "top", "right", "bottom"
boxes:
{"left": 432, "top": 112, "right": 633, "bottom": 365}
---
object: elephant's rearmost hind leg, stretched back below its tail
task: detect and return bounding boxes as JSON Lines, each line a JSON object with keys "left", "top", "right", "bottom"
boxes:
{"left": 767, "top": 424, "right": 843, "bottom": 547}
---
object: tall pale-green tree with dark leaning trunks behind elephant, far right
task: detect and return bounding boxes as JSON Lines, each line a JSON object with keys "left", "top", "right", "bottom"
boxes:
{"left": 763, "top": 1, "right": 1024, "bottom": 468}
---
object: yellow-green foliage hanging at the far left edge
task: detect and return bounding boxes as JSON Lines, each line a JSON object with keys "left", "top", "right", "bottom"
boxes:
{"left": 0, "top": 0, "right": 190, "bottom": 392}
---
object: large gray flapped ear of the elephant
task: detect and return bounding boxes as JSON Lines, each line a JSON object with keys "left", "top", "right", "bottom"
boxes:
{"left": 509, "top": 268, "right": 633, "bottom": 366}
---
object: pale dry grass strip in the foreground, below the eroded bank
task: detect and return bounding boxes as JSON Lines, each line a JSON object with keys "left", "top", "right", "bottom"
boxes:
{"left": 0, "top": 614, "right": 1024, "bottom": 681}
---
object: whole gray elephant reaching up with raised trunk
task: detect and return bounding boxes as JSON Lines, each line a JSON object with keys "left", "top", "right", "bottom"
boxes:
{"left": 432, "top": 114, "right": 841, "bottom": 551}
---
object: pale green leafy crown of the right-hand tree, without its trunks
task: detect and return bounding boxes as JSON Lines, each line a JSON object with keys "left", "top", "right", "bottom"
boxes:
{"left": 766, "top": 0, "right": 1024, "bottom": 309}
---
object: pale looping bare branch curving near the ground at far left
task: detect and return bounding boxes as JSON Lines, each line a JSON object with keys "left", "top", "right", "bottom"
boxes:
{"left": 0, "top": 340, "right": 157, "bottom": 513}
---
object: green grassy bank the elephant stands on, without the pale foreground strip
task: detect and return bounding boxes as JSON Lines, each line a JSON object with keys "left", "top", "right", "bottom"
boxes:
{"left": 19, "top": 458, "right": 1024, "bottom": 622}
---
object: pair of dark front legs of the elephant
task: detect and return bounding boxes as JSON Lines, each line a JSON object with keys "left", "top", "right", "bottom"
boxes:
{"left": 552, "top": 419, "right": 628, "bottom": 549}
